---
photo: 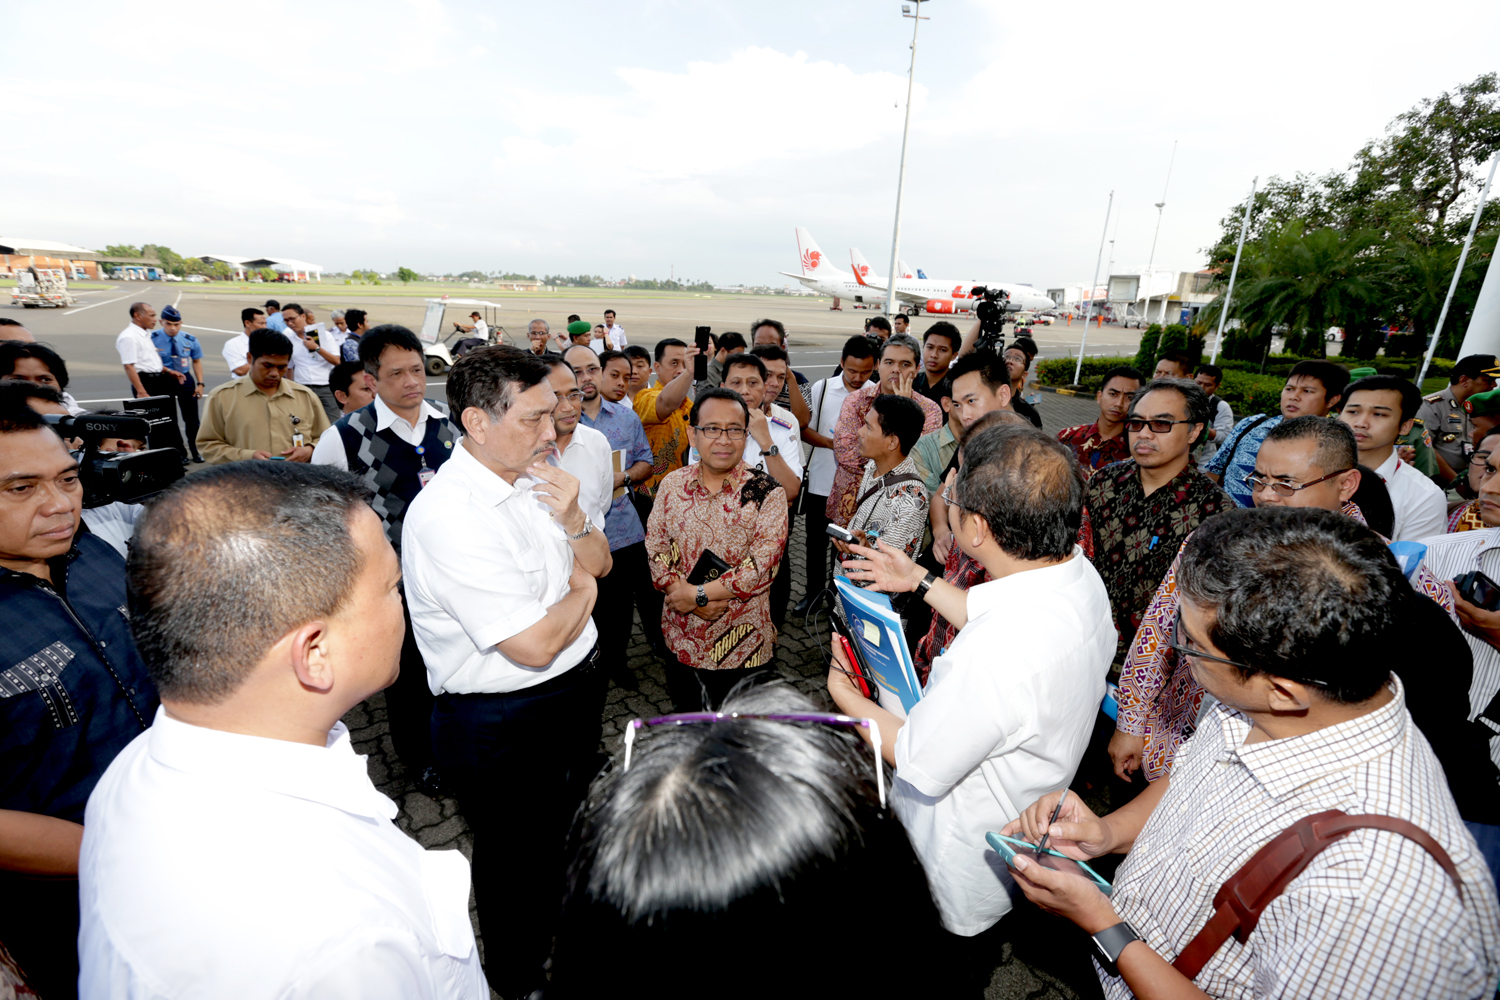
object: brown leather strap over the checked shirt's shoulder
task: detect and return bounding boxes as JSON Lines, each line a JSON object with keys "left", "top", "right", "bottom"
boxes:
{"left": 1172, "top": 810, "right": 1464, "bottom": 979}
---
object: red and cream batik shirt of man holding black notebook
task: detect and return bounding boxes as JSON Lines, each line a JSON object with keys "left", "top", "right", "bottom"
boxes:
{"left": 647, "top": 462, "right": 788, "bottom": 670}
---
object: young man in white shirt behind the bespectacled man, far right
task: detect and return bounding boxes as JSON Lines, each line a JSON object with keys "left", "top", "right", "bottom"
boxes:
{"left": 1340, "top": 375, "right": 1448, "bottom": 541}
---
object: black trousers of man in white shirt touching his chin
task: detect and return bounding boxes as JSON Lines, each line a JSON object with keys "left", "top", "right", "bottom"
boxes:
{"left": 432, "top": 648, "right": 605, "bottom": 1000}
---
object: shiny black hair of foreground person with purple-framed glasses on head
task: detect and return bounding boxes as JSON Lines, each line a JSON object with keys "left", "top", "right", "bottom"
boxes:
{"left": 548, "top": 684, "right": 942, "bottom": 1000}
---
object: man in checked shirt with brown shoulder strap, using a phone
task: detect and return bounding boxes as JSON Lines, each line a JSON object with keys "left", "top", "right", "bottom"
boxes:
{"left": 1002, "top": 510, "right": 1500, "bottom": 1000}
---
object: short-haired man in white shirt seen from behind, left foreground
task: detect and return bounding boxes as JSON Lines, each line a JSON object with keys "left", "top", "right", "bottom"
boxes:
{"left": 78, "top": 462, "right": 486, "bottom": 1000}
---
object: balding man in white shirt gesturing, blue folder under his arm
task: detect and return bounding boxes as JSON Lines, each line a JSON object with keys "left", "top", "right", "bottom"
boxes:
{"left": 828, "top": 424, "right": 1115, "bottom": 937}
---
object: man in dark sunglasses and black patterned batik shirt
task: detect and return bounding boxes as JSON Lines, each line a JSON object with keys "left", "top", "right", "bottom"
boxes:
{"left": 1080, "top": 378, "right": 1233, "bottom": 663}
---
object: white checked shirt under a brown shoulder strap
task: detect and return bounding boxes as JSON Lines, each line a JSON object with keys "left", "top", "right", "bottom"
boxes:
{"left": 1100, "top": 676, "right": 1500, "bottom": 1000}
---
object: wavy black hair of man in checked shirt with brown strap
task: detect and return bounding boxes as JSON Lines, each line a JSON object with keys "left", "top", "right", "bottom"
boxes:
{"left": 1178, "top": 507, "right": 1404, "bottom": 705}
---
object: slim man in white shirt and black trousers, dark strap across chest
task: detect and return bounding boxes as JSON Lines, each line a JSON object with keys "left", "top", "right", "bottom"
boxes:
{"left": 792, "top": 336, "right": 875, "bottom": 615}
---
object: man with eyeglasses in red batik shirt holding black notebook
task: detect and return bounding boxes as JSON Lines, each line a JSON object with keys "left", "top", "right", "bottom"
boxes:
{"left": 647, "top": 388, "right": 788, "bottom": 712}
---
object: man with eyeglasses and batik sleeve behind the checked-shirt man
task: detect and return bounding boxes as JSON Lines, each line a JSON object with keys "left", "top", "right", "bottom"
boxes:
{"left": 1109, "top": 417, "right": 1454, "bottom": 781}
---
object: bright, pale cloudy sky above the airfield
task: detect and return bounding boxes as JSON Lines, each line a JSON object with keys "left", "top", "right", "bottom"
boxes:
{"left": 0, "top": 0, "right": 1500, "bottom": 288}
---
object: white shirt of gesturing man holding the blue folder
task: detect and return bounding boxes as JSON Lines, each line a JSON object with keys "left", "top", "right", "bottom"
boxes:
{"left": 891, "top": 547, "right": 1115, "bottom": 937}
